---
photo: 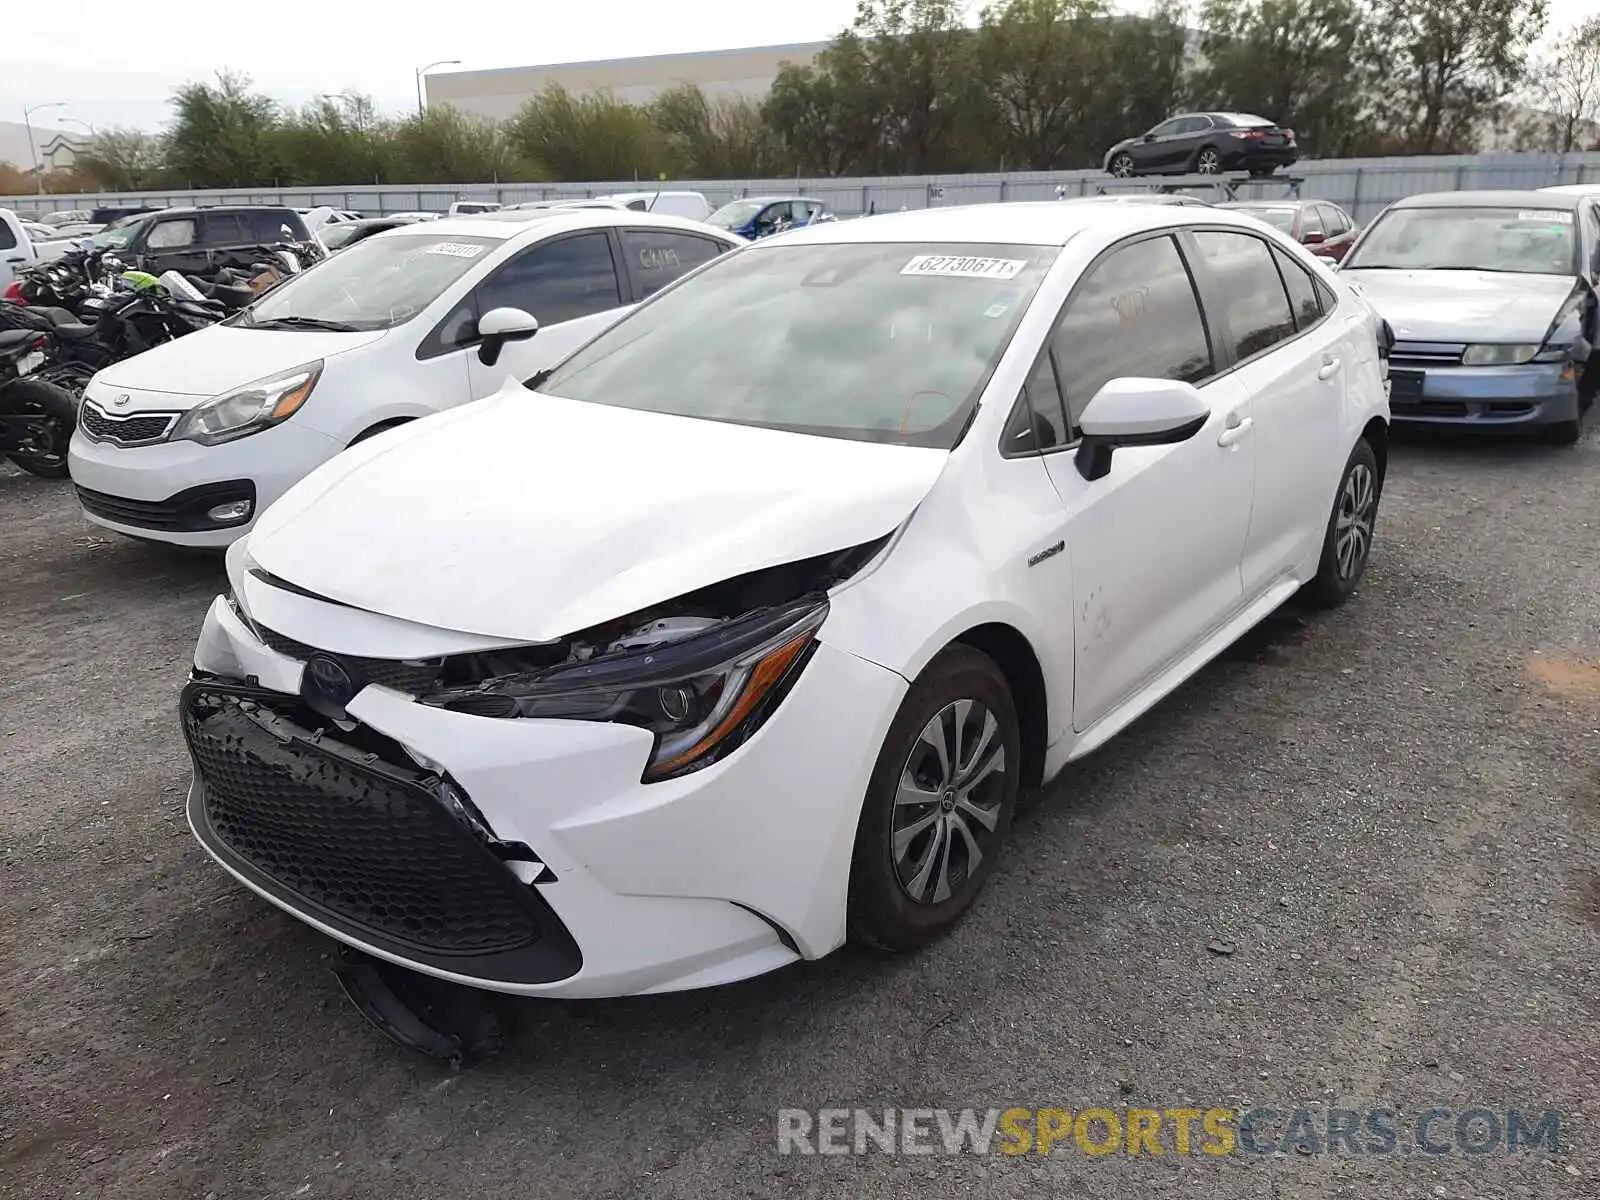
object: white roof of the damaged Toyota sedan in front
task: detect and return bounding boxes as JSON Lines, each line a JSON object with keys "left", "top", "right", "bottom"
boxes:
{"left": 760, "top": 198, "right": 1259, "bottom": 246}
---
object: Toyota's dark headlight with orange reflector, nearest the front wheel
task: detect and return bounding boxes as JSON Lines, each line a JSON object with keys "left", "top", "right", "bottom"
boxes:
{"left": 426, "top": 597, "right": 827, "bottom": 782}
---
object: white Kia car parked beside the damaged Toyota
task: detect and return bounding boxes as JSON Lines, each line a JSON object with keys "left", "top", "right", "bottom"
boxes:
{"left": 69, "top": 210, "right": 742, "bottom": 547}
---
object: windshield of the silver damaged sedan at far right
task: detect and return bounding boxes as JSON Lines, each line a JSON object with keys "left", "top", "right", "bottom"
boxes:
{"left": 1344, "top": 208, "right": 1578, "bottom": 275}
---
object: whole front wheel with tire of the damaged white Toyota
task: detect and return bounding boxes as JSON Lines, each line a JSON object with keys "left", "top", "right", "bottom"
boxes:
{"left": 850, "top": 645, "right": 1022, "bottom": 950}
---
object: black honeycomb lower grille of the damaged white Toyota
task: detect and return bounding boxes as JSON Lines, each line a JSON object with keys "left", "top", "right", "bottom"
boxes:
{"left": 182, "top": 683, "right": 547, "bottom": 955}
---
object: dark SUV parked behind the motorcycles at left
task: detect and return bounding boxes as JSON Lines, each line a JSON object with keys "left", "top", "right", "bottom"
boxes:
{"left": 104, "top": 205, "right": 310, "bottom": 277}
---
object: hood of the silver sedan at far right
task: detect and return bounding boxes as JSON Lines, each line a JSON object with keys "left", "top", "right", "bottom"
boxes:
{"left": 1339, "top": 269, "right": 1576, "bottom": 342}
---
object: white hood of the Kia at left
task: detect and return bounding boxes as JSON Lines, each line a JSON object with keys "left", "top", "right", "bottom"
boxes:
{"left": 96, "top": 325, "right": 384, "bottom": 403}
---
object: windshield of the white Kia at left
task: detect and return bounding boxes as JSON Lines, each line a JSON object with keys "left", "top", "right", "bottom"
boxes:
{"left": 238, "top": 234, "right": 501, "bottom": 330}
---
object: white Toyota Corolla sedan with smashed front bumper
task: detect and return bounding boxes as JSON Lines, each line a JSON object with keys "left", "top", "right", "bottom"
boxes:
{"left": 182, "top": 203, "right": 1389, "bottom": 997}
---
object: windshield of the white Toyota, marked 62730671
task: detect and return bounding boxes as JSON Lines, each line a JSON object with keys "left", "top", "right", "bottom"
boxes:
{"left": 541, "top": 243, "right": 1059, "bottom": 450}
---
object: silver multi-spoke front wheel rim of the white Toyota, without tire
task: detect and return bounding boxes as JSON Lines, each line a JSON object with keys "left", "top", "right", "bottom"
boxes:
{"left": 890, "top": 699, "right": 1008, "bottom": 904}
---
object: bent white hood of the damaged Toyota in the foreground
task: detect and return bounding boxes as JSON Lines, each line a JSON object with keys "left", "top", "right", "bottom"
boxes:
{"left": 246, "top": 382, "right": 949, "bottom": 642}
